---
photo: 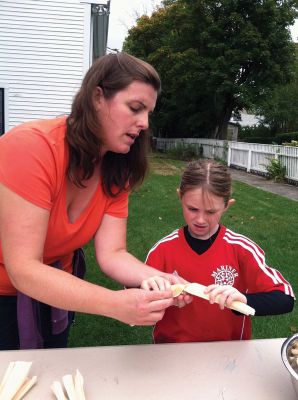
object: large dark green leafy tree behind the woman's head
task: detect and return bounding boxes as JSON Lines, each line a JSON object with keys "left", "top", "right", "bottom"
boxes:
{"left": 124, "top": 0, "right": 298, "bottom": 138}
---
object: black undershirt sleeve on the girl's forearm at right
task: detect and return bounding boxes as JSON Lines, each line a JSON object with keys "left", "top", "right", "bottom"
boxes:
{"left": 245, "top": 290, "right": 294, "bottom": 316}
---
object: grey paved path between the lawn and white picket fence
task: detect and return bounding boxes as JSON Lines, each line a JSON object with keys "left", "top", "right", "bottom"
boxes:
{"left": 230, "top": 168, "right": 298, "bottom": 201}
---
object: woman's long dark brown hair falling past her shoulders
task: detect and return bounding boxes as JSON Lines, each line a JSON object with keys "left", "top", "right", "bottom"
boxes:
{"left": 66, "top": 53, "right": 161, "bottom": 196}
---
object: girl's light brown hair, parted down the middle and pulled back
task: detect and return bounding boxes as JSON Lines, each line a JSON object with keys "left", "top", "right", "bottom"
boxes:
{"left": 179, "top": 159, "right": 232, "bottom": 206}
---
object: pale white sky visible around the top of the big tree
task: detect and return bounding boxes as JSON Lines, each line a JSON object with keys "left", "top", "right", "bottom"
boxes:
{"left": 108, "top": 0, "right": 298, "bottom": 50}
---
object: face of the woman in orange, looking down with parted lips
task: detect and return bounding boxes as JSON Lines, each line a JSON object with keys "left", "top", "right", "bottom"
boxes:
{"left": 94, "top": 81, "right": 157, "bottom": 155}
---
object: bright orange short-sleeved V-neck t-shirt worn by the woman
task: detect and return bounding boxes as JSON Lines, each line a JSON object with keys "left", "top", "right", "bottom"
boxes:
{"left": 0, "top": 117, "right": 128, "bottom": 295}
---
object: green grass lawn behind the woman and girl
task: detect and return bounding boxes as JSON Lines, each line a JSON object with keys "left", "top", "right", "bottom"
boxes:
{"left": 70, "top": 156, "right": 298, "bottom": 347}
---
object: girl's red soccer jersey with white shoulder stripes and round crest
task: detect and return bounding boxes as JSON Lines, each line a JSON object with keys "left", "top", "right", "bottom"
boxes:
{"left": 146, "top": 226, "right": 294, "bottom": 343}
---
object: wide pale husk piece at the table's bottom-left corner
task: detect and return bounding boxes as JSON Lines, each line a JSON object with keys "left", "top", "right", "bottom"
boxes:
{"left": 0, "top": 361, "right": 32, "bottom": 400}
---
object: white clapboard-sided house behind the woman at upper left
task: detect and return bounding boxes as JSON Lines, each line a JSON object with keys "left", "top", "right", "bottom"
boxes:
{"left": 0, "top": 0, "right": 110, "bottom": 134}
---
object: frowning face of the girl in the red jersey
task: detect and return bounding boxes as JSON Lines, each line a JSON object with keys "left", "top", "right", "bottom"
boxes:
{"left": 180, "top": 188, "right": 228, "bottom": 239}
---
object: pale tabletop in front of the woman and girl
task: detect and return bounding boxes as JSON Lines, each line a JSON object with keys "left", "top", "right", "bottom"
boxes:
{"left": 0, "top": 339, "right": 297, "bottom": 400}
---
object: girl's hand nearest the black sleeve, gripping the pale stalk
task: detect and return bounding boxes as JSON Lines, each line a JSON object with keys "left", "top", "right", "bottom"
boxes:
{"left": 205, "top": 285, "right": 247, "bottom": 310}
